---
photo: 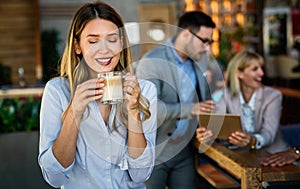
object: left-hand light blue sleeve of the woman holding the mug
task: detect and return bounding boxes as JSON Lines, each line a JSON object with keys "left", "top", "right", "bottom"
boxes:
{"left": 38, "top": 80, "right": 74, "bottom": 187}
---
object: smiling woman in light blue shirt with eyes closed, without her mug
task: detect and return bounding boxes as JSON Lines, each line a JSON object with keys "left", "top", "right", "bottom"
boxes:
{"left": 38, "top": 2, "right": 156, "bottom": 189}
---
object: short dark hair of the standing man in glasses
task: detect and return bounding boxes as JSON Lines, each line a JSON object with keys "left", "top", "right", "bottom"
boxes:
{"left": 178, "top": 11, "right": 216, "bottom": 32}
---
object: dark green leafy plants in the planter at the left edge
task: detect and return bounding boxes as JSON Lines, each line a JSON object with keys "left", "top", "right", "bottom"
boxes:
{"left": 0, "top": 97, "right": 41, "bottom": 133}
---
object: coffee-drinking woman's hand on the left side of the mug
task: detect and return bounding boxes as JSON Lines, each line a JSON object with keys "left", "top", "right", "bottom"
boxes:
{"left": 72, "top": 78, "right": 104, "bottom": 125}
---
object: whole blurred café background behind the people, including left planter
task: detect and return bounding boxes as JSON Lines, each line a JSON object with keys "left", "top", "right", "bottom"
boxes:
{"left": 0, "top": 0, "right": 300, "bottom": 189}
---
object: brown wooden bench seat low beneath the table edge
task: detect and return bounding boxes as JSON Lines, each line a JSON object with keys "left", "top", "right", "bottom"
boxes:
{"left": 197, "top": 163, "right": 241, "bottom": 189}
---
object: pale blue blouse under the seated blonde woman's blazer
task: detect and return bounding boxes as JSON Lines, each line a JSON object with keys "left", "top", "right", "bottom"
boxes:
{"left": 239, "top": 92, "right": 266, "bottom": 149}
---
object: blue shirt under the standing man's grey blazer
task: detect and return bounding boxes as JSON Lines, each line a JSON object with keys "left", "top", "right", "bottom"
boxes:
{"left": 172, "top": 48, "right": 197, "bottom": 138}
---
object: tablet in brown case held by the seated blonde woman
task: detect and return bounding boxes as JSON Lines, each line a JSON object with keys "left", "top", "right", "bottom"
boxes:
{"left": 198, "top": 113, "right": 243, "bottom": 140}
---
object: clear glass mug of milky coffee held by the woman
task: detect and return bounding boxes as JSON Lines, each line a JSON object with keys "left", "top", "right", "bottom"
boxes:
{"left": 98, "top": 72, "right": 124, "bottom": 104}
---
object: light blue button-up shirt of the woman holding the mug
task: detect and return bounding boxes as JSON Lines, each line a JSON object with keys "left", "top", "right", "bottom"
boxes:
{"left": 38, "top": 77, "right": 157, "bottom": 189}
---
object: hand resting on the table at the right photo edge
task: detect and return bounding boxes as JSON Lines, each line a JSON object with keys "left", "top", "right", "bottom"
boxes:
{"left": 261, "top": 149, "right": 299, "bottom": 167}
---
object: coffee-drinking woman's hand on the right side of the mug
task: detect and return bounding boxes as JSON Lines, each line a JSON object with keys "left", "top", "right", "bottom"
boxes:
{"left": 124, "top": 73, "right": 141, "bottom": 112}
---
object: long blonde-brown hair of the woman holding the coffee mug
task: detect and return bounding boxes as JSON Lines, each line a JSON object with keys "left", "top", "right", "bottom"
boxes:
{"left": 60, "top": 2, "right": 151, "bottom": 131}
